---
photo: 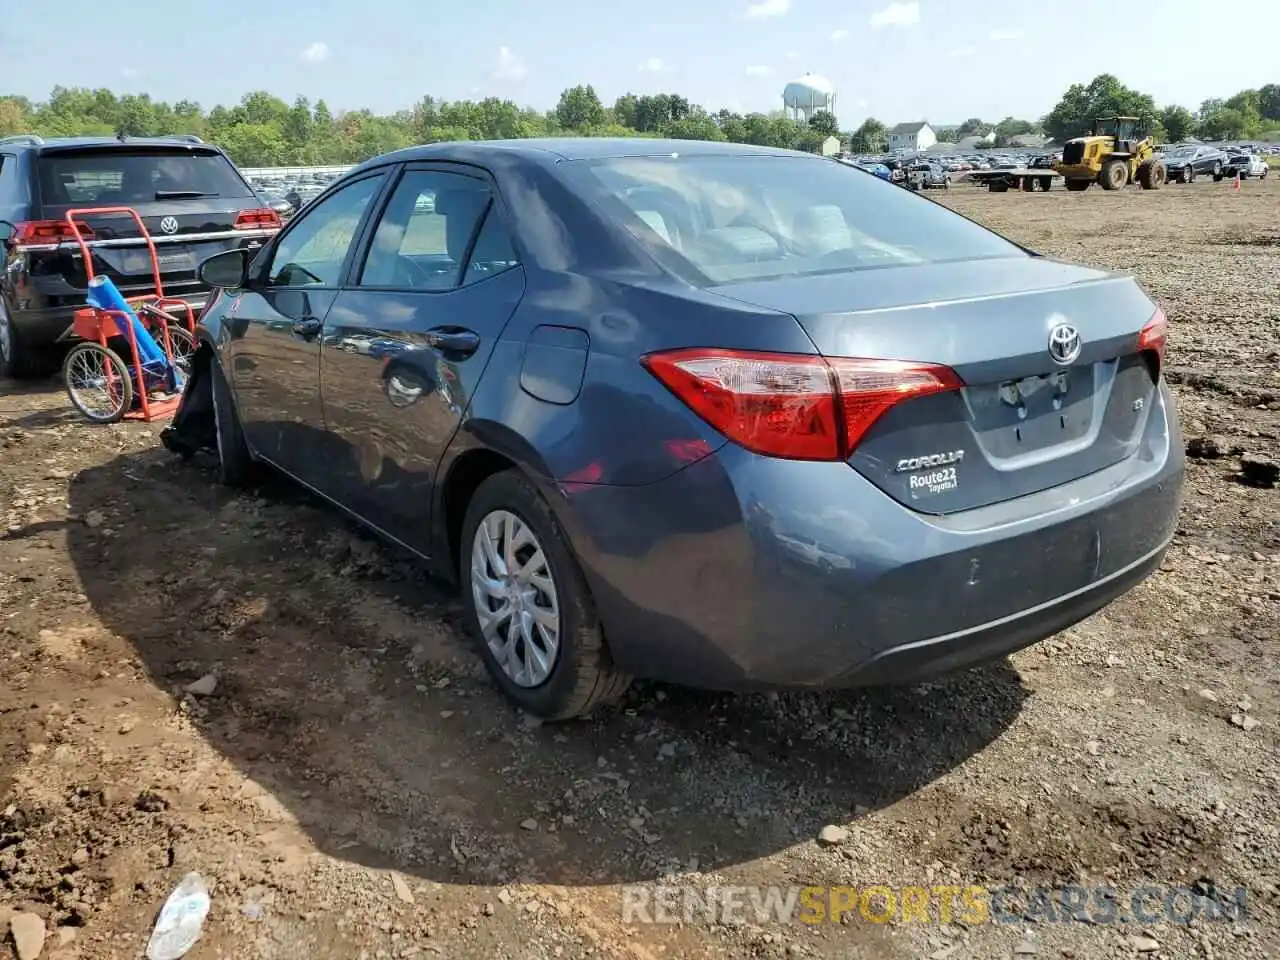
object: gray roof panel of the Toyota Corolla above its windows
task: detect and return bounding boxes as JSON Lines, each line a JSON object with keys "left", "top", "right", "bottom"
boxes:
{"left": 357, "top": 137, "right": 814, "bottom": 175}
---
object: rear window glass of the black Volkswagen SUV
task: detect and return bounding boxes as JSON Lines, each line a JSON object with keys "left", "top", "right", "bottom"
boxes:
{"left": 40, "top": 148, "right": 252, "bottom": 206}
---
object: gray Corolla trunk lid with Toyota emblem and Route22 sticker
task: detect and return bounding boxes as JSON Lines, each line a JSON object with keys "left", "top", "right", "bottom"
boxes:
{"left": 714, "top": 256, "right": 1158, "bottom": 513}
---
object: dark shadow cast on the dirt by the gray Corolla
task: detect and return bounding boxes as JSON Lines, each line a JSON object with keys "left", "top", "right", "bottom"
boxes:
{"left": 68, "top": 449, "right": 1025, "bottom": 884}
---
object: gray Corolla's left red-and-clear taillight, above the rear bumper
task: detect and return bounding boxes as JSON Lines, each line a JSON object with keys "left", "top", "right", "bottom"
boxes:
{"left": 641, "top": 348, "right": 964, "bottom": 461}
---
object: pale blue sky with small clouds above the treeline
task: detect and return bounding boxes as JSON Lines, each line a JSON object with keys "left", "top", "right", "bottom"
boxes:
{"left": 0, "top": 0, "right": 1280, "bottom": 129}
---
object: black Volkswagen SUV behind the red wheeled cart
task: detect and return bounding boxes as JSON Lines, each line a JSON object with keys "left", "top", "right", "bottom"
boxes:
{"left": 0, "top": 134, "right": 280, "bottom": 378}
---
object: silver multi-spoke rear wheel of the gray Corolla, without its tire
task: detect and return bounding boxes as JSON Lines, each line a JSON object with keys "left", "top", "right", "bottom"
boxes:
{"left": 471, "top": 509, "right": 561, "bottom": 687}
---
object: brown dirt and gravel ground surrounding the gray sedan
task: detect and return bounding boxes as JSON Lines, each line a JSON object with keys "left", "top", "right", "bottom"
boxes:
{"left": 0, "top": 178, "right": 1280, "bottom": 960}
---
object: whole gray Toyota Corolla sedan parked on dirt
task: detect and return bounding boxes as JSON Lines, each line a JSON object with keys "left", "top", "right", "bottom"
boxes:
{"left": 165, "top": 138, "right": 1183, "bottom": 718}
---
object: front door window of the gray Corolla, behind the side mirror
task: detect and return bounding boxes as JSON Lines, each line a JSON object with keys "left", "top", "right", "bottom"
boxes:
{"left": 268, "top": 177, "right": 383, "bottom": 287}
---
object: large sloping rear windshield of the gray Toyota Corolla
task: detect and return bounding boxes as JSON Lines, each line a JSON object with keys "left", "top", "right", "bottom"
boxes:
{"left": 562, "top": 155, "right": 1025, "bottom": 284}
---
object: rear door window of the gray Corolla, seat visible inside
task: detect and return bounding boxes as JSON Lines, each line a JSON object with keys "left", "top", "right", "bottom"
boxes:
{"left": 360, "top": 170, "right": 492, "bottom": 291}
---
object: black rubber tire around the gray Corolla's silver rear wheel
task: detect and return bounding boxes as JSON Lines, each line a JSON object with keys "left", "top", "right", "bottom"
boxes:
{"left": 458, "top": 470, "right": 631, "bottom": 721}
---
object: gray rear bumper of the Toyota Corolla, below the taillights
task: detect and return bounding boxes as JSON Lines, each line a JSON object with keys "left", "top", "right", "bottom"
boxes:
{"left": 562, "top": 390, "right": 1184, "bottom": 690}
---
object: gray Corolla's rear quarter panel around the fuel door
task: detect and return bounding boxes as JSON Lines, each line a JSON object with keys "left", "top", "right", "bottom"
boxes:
{"left": 463, "top": 271, "right": 814, "bottom": 485}
